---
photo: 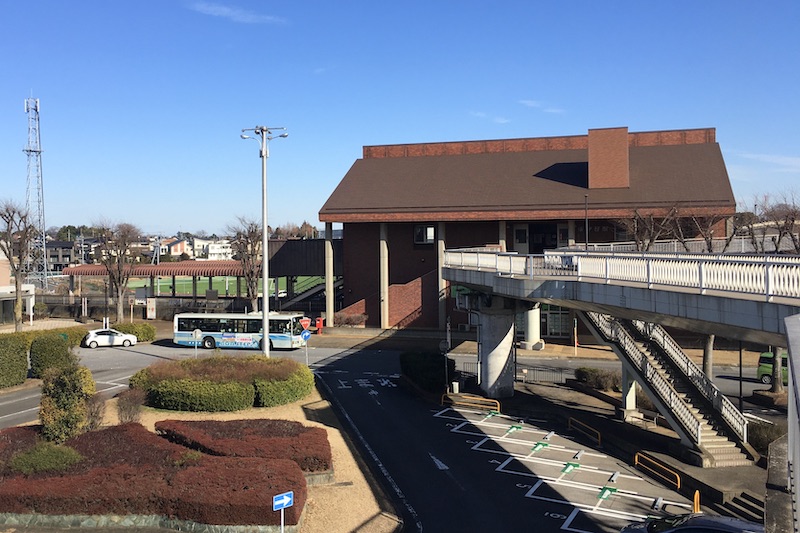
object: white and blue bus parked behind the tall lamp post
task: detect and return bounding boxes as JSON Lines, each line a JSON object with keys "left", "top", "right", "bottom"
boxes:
{"left": 172, "top": 311, "right": 303, "bottom": 350}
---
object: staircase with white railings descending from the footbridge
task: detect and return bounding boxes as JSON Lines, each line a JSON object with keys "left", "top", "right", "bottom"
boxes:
{"left": 583, "top": 312, "right": 758, "bottom": 467}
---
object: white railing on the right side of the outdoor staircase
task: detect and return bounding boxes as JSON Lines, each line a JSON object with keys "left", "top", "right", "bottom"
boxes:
{"left": 631, "top": 320, "right": 747, "bottom": 442}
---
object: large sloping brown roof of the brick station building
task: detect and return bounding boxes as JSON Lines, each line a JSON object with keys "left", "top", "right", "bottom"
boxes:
{"left": 319, "top": 129, "right": 736, "bottom": 222}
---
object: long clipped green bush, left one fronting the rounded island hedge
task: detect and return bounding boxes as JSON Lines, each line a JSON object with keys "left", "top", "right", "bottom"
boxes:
{"left": 147, "top": 379, "right": 255, "bottom": 412}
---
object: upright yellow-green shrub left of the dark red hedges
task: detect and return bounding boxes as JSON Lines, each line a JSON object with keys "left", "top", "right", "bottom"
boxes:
{"left": 39, "top": 364, "right": 95, "bottom": 443}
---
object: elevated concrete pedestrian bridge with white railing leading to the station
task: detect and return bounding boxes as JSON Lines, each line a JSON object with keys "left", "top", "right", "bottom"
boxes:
{"left": 443, "top": 249, "right": 800, "bottom": 346}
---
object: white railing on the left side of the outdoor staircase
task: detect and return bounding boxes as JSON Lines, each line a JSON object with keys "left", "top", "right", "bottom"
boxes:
{"left": 586, "top": 311, "right": 701, "bottom": 445}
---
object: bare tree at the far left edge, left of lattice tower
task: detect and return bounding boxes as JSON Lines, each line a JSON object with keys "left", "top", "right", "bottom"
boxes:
{"left": 0, "top": 200, "right": 36, "bottom": 331}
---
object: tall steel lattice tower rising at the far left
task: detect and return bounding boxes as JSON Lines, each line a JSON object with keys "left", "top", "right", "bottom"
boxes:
{"left": 23, "top": 98, "right": 48, "bottom": 289}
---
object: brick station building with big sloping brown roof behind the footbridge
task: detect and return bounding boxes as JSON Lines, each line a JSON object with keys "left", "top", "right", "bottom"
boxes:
{"left": 319, "top": 127, "right": 736, "bottom": 337}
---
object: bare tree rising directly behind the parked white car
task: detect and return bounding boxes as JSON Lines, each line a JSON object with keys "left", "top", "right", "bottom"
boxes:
{"left": 95, "top": 222, "right": 142, "bottom": 322}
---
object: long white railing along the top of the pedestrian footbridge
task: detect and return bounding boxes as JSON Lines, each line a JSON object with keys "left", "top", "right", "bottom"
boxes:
{"left": 444, "top": 250, "right": 800, "bottom": 301}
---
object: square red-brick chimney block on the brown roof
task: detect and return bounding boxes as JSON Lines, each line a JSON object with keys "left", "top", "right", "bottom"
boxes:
{"left": 589, "top": 127, "right": 630, "bottom": 189}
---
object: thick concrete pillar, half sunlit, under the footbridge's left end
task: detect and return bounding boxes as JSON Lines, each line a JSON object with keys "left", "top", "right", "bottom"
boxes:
{"left": 479, "top": 296, "right": 515, "bottom": 399}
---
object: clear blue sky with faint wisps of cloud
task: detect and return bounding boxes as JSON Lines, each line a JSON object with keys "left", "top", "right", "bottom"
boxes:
{"left": 0, "top": 0, "right": 800, "bottom": 235}
